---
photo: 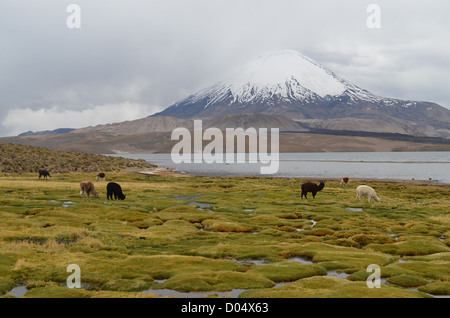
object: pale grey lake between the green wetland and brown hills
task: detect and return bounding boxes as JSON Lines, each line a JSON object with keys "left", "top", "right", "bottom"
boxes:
{"left": 110, "top": 151, "right": 450, "bottom": 183}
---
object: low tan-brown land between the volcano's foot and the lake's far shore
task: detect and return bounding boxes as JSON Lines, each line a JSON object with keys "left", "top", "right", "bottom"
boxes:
{"left": 0, "top": 128, "right": 450, "bottom": 154}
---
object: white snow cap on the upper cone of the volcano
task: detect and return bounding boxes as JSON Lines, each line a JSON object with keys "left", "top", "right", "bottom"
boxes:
{"left": 193, "top": 50, "right": 375, "bottom": 106}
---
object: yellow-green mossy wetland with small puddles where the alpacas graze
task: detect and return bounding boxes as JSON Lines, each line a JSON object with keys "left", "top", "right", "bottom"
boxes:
{"left": 0, "top": 171, "right": 450, "bottom": 298}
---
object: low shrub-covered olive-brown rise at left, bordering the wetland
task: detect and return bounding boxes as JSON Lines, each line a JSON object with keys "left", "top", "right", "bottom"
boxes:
{"left": 0, "top": 142, "right": 154, "bottom": 174}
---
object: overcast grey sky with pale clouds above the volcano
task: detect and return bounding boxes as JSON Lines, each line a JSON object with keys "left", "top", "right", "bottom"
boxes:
{"left": 0, "top": 0, "right": 450, "bottom": 136}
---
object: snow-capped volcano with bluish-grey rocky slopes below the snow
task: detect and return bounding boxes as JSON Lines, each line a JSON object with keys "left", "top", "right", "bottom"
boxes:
{"left": 153, "top": 50, "right": 450, "bottom": 137}
